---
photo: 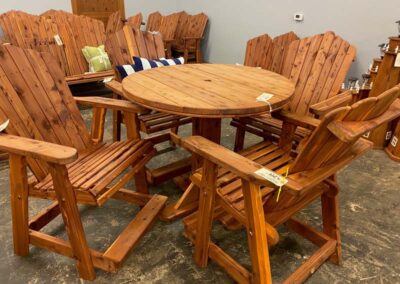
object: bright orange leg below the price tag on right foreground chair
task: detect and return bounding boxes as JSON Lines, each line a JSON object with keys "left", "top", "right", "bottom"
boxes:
{"left": 242, "top": 180, "right": 272, "bottom": 284}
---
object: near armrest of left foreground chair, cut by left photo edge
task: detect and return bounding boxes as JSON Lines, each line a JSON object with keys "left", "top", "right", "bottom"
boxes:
{"left": 0, "top": 134, "right": 78, "bottom": 165}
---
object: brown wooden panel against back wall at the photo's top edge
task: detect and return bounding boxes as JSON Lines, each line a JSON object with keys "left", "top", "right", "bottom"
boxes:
{"left": 71, "top": 0, "right": 125, "bottom": 25}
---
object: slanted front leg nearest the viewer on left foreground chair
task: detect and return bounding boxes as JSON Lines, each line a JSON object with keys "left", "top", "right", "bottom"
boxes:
{"left": 49, "top": 164, "right": 96, "bottom": 280}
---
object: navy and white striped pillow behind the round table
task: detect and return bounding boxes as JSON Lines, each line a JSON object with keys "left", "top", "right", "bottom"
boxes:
{"left": 116, "top": 56, "right": 185, "bottom": 79}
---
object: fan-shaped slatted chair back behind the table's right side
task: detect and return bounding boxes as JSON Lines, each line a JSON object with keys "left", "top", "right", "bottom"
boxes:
{"left": 282, "top": 32, "right": 356, "bottom": 115}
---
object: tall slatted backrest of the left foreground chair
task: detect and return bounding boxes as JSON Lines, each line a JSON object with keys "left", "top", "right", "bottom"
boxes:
{"left": 0, "top": 45, "right": 92, "bottom": 181}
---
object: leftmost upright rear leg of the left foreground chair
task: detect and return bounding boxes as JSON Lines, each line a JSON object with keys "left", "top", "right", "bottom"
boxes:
{"left": 10, "top": 155, "right": 29, "bottom": 256}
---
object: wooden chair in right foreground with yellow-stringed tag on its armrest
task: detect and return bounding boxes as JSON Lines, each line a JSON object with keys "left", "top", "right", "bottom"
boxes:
{"left": 181, "top": 87, "right": 400, "bottom": 284}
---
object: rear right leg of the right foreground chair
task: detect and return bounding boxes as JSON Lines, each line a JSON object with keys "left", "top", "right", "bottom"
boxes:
{"left": 321, "top": 186, "right": 342, "bottom": 265}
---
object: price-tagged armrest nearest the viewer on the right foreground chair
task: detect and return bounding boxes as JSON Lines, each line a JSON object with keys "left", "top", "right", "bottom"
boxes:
{"left": 180, "top": 136, "right": 294, "bottom": 187}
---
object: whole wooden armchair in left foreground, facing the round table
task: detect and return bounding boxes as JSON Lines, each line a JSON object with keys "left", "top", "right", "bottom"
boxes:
{"left": 0, "top": 45, "right": 166, "bottom": 280}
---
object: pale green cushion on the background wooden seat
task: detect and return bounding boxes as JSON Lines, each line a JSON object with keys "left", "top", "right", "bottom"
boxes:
{"left": 82, "top": 45, "right": 112, "bottom": 73}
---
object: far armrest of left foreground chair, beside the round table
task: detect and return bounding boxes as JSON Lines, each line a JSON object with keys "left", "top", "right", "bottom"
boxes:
{"left": 75, "top": 97, "right": 146, "bottom": 113}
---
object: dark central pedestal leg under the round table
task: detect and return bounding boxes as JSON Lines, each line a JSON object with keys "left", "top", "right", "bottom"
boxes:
{"left": 160, "top": 118, "right": 221, "bottom": 221}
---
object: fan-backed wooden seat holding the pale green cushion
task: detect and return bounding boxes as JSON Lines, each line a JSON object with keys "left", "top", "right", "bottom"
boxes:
{"left": 42, "top": 10, "right": 113, "bottom": 85}
